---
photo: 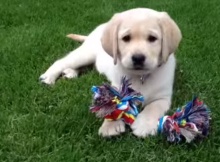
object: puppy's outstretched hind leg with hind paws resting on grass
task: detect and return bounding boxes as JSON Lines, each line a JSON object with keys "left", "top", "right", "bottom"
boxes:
{"left": 40, "top": 43, "right": 96, "bottom": 84}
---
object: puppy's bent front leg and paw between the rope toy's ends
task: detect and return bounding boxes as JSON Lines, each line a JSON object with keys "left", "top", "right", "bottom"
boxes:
{"left": 131, "top": 99, "right": 170, "bottom": 137}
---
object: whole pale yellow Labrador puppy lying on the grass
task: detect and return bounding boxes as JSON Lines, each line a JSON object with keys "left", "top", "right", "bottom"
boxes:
{"left": 40, "top": 8, "right": 182, "bottom": 137}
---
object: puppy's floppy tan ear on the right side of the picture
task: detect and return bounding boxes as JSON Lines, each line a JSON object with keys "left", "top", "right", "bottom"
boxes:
{"left": 159, "top": 12, "right": 182, "bottom": 63}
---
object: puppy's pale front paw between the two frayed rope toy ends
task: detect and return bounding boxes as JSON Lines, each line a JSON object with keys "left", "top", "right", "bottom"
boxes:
{"left": 131, "top": 114, "right": 158, "bottom": 138}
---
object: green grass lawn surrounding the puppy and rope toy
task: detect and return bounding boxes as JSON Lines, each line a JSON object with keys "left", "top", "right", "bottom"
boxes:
{"left": 0, "top": 0, "right": 220, "bottom": 162}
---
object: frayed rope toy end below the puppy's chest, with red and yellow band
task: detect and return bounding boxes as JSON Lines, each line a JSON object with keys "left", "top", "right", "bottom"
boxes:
{"left": 90, "top": 77, "right": 144, "bottom": 125}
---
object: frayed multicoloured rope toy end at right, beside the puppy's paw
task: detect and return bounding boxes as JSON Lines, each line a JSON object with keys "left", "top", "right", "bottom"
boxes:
{"left": 158, "top": 97, "right": 211, "bottom": 143}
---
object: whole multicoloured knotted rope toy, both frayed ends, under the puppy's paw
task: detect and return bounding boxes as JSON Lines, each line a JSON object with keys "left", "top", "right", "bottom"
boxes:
{"left": 90, "top": 77, "right": 211, "bottom": 142}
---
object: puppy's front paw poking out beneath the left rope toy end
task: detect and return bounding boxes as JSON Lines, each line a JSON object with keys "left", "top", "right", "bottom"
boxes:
{"left": 99, "top": 120, "right": 125, "bottom": 137}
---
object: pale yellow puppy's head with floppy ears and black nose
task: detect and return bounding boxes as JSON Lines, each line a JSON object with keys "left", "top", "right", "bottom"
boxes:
{"left": 101, "top": 9, "right": 181, "bottom": 72}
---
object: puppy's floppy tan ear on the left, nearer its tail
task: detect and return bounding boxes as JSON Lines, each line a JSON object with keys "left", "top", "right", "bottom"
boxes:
{"left": 101, "top": 14, "right": 121, "bottom": 64}
